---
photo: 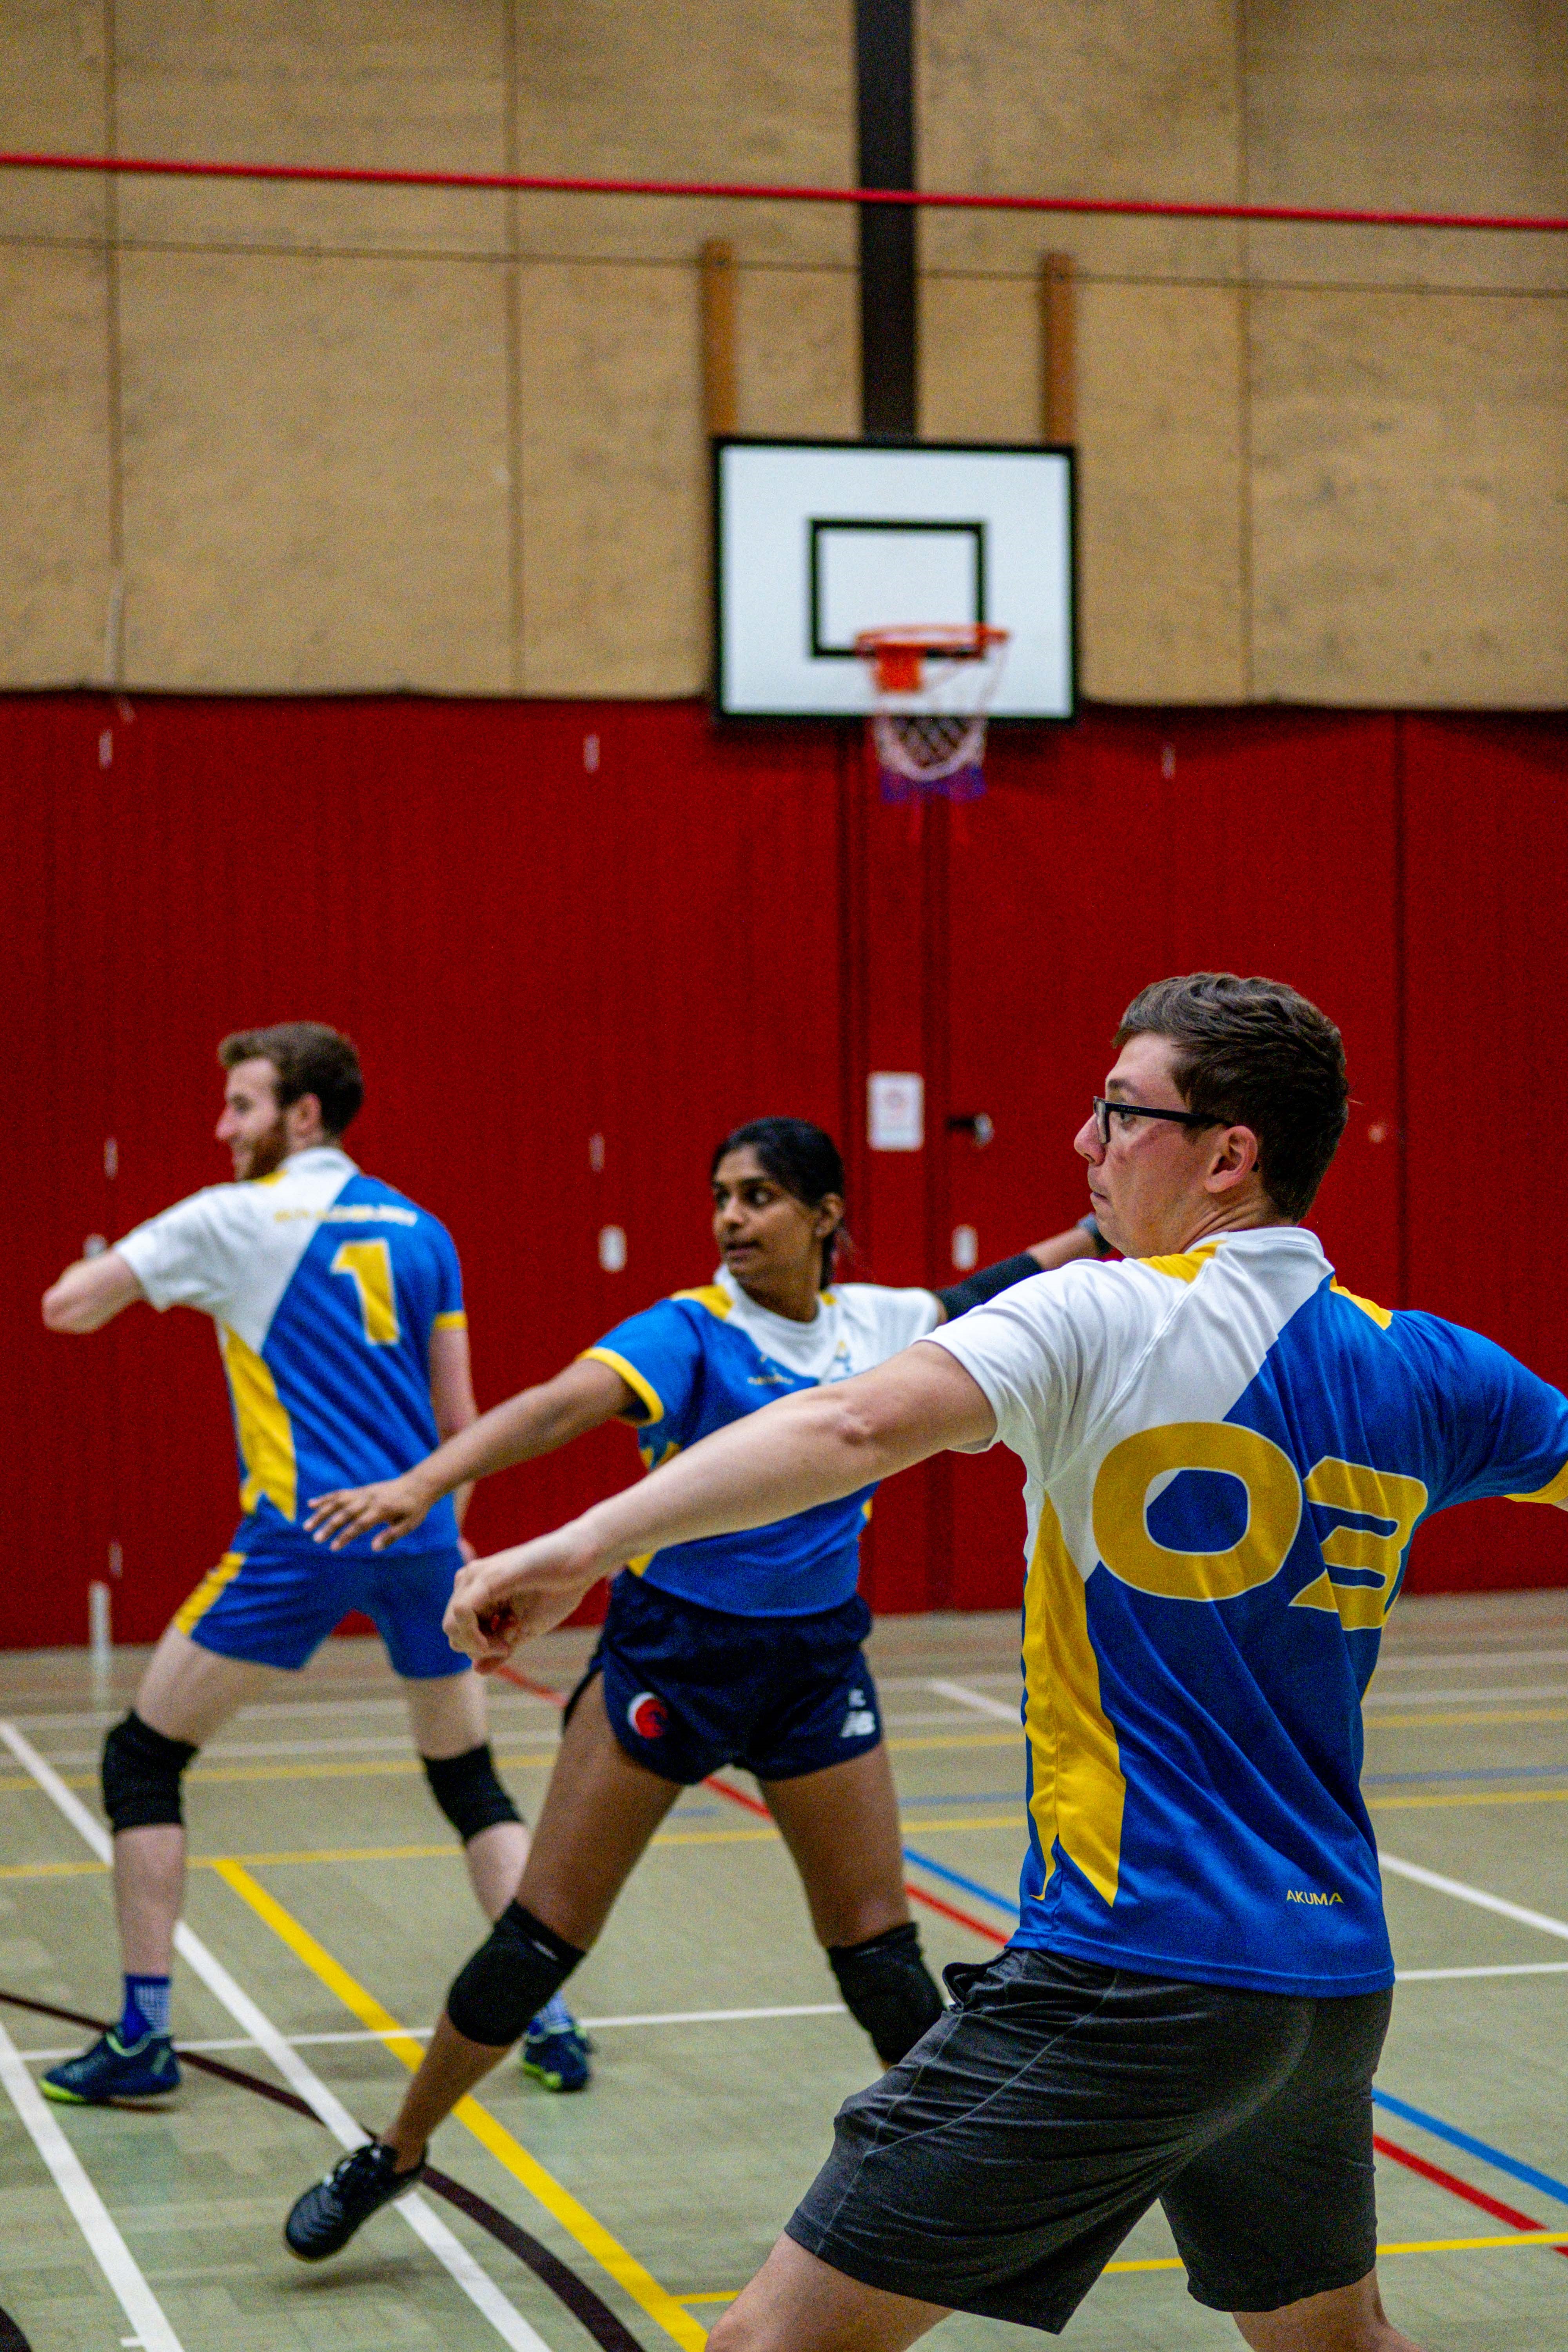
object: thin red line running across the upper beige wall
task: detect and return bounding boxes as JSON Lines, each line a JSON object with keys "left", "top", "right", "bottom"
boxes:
{"left": 0, "top": 151, "right": 1568, "bottom": 235}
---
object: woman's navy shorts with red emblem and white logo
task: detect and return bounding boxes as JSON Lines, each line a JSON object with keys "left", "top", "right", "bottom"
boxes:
{"left": 566, "top": 1571, "right": 882, "bottom": 1785}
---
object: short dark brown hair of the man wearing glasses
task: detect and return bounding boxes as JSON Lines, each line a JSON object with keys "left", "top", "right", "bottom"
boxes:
{"left": 1117, "top": 971, "right": 1349, "bottom": 1221}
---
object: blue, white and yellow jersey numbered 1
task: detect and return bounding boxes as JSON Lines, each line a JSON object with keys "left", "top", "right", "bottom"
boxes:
{"left": 115, "top": 1145, "right": 468, "bottom": 1552}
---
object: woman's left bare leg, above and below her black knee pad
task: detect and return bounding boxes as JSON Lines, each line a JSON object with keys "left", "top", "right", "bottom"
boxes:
{"left": 381, "top": 1677, "right": 679, "bottom": 2173}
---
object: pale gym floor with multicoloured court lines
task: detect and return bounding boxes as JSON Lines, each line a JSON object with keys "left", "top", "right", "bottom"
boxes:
{"left": 0, "top": 1592, "right": 1568, "bottom": 2352}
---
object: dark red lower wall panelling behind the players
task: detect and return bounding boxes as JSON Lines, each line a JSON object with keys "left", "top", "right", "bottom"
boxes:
{"left": 0, "top": 696, "right": 1568, "bottom": 1646}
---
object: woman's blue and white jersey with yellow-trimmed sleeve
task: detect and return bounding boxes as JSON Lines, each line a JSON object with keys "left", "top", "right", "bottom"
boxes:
{"left": 585, "top": 1268, "right": 938, "bottom": 1616}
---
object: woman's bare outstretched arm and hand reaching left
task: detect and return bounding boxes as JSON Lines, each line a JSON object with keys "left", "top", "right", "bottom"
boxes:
{"left": 306, "top": 1334, "right": 642, "bottom": 1552}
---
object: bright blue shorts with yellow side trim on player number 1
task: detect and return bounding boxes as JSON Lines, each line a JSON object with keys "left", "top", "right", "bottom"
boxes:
{"left": 174, "top": 1538, "right": 468, "bottom": 1682}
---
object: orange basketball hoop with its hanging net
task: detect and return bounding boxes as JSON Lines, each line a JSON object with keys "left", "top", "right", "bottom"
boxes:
{"left": 856, "top": 621, "right": 1009, "bottom": 800}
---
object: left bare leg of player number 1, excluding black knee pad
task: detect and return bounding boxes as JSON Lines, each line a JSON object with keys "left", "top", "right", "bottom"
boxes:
{"left": 115, "top": 1625, "right": 287, "bottom": 1976}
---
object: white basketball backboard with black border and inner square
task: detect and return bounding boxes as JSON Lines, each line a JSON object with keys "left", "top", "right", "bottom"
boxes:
{"left": 712, "top": 440, "right": 1074, "bottom": 720}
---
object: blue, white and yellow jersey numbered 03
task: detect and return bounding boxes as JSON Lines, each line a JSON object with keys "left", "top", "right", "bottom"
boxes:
{"left": 936, "top": 1225, "right": 1568, "bottom": 1994}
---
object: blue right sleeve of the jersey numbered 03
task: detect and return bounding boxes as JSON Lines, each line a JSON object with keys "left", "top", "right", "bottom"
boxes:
{"left": 1401, "top": 1315, "right": 1568, "bottom": 1510}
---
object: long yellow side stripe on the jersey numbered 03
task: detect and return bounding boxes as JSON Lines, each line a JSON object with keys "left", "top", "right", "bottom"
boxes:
{"left": 1023, "top": 1496, "right": 1126, "bottom": 1903}
